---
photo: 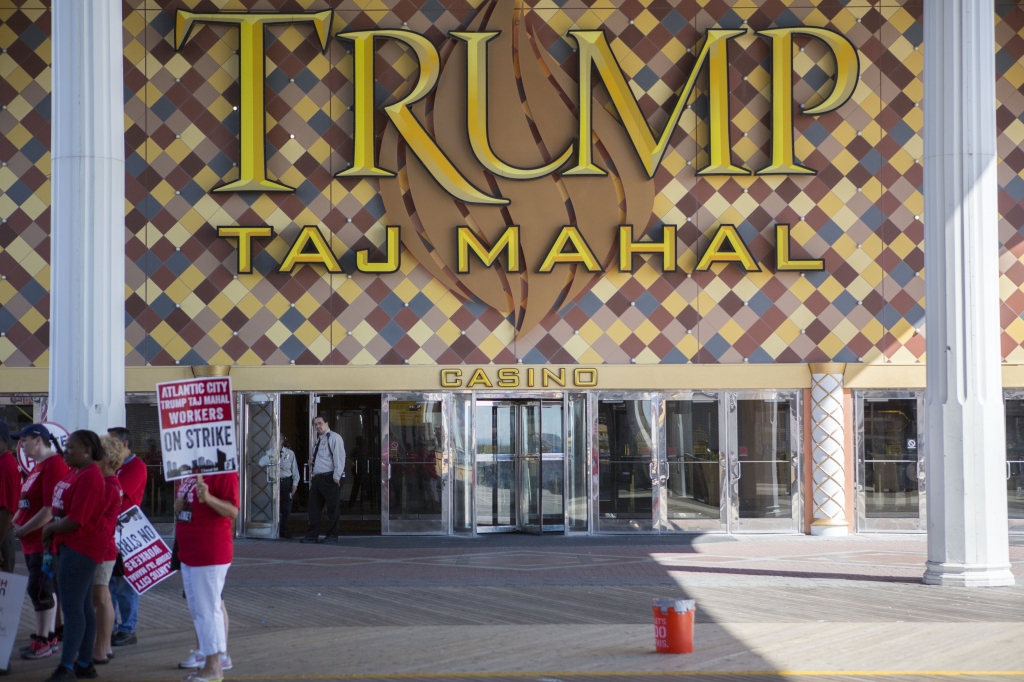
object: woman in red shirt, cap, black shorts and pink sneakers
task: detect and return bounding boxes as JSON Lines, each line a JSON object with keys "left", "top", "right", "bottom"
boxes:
{"left": 12, "top": 424, "right": 68, "bottom": 660}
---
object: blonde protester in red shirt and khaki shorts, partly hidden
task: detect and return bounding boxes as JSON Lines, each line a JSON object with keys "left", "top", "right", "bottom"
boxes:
{"left": 92, "top": 435, "right": 125, "bottom": 666}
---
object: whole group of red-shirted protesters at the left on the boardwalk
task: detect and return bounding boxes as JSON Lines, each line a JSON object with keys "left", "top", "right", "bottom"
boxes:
{"left": 0, "top": 421, "right": 239, "bottom": 682}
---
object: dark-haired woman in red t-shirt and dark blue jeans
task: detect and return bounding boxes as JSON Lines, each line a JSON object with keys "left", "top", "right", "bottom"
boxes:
{"left": 43, "top": 430, "right": 110, "bottom": 682}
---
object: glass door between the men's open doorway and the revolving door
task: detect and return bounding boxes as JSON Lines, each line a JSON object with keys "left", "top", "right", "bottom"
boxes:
{"left": 381, "top": 393, "right": 452, "bottom": 535}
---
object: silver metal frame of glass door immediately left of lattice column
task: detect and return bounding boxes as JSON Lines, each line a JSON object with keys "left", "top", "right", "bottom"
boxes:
{"left": 723, "top": 390, "right": 804, "bottom": 535}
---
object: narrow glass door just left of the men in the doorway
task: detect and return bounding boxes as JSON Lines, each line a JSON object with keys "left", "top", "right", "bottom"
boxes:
{"left": 239, "top": 393, "right": 281, "bottom": 538}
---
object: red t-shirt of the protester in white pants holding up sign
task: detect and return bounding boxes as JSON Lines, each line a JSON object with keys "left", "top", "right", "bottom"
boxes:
{"left": 174, "top": 473, "right": 239, "bottom": 566}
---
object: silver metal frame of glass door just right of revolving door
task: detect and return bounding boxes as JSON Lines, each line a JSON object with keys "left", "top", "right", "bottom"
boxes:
{"left": 587, "top": 391, "right": 665, "bottom": 535}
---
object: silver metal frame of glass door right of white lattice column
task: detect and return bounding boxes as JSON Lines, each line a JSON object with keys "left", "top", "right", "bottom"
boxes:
{"left": 853, "top": 389, "right": 925, "bottom": 532}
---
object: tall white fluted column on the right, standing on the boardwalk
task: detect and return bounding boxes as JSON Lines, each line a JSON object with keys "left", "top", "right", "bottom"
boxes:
{"left": 924, "top": 0, "right": 1014, "bottom": 586}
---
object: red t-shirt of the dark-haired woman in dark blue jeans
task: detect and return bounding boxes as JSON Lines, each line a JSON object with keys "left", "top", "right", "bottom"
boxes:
{"left": 52, "top": 464, "right": 110, "bottom": 563}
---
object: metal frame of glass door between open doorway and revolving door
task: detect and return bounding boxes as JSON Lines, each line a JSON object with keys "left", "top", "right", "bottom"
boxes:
{"left": 381, "top": 391, "right": 453, "bottom": 536}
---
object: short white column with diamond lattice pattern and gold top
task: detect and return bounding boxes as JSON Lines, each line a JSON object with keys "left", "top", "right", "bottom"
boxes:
{"left": 810, "top": 363, "right": 849, "bottom": 536}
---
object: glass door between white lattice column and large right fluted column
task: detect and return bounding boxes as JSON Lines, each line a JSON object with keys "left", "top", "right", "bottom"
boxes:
{"left": 856, "top": 391, "right": 927, "bottom": 532}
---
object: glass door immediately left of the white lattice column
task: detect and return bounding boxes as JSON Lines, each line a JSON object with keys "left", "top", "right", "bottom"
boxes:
{"left": 727, "top": 391, "right": 801, "bottom": 532}
